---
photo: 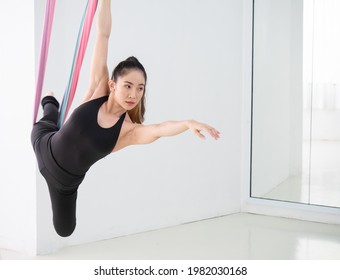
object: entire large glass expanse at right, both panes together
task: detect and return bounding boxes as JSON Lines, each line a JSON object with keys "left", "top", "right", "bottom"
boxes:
{"left": 251, "top": 0, "right": 340, "bottom": 207}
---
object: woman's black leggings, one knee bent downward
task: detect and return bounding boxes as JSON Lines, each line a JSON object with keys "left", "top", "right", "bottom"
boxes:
{"left": 31, "top": 96, "right": 84, "bottom": 237}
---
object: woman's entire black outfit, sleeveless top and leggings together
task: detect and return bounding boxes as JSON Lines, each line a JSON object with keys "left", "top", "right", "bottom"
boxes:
{"left": 31, "top": 96, "right": 126, "bottom": 237}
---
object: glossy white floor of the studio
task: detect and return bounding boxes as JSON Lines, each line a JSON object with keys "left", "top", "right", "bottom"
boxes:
{"left": 0, "top": 213, "right": 340, "bottom": 260}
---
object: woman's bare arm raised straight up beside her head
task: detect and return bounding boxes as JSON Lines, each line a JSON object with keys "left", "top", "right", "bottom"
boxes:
{"left": 83, "top": 0, "right": 112, "bottom": 102}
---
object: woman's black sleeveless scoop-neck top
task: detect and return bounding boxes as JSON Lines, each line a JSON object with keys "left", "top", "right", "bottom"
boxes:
{"left": 51, "top": 96, "right": 126, "bottom": 175}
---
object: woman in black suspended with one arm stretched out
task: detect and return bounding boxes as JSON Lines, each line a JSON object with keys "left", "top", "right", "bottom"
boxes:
{"left": 31, "top": 0, "right": 219, "bottom": 237}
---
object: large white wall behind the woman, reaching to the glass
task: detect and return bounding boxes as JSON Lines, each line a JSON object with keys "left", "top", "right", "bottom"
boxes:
{"left": 36, "top": 0, "right": 243, "bottom": 253}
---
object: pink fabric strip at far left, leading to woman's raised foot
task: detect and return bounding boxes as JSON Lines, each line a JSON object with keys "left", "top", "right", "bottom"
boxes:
{"left": 33, "top": 0, "right": 56, "bottom": 124}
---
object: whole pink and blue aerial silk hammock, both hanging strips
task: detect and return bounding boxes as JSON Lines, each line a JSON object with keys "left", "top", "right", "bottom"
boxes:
{"left": 33, "top": 0, "right": 98, "bottom": 128}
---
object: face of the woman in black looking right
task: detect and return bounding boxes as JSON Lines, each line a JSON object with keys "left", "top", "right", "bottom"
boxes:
{"left": 113, "top": 70, "right": 145, "bottom": 111}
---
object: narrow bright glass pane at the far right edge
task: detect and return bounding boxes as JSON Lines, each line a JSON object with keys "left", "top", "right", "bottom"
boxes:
{"left": 310, "top": 0, "right": 340, "bottom": 207}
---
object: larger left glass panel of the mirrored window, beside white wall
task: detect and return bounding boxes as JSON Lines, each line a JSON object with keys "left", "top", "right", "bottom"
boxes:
{"left": 251, "top": 0, "right": 310, "bottom": 203}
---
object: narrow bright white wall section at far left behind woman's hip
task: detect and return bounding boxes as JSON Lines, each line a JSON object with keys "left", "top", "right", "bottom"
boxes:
{"left": 0, "top": 0, "right": 36, "bottom": 254}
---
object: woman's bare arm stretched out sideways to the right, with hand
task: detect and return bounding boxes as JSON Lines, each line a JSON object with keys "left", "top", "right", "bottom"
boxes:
{"left": 129, "top": 120, "right": 220, "bottom": 145}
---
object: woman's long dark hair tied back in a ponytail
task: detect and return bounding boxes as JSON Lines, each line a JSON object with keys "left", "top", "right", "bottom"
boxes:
{"left": 111, "top": 56, "right": 147, "bottom": 124}
